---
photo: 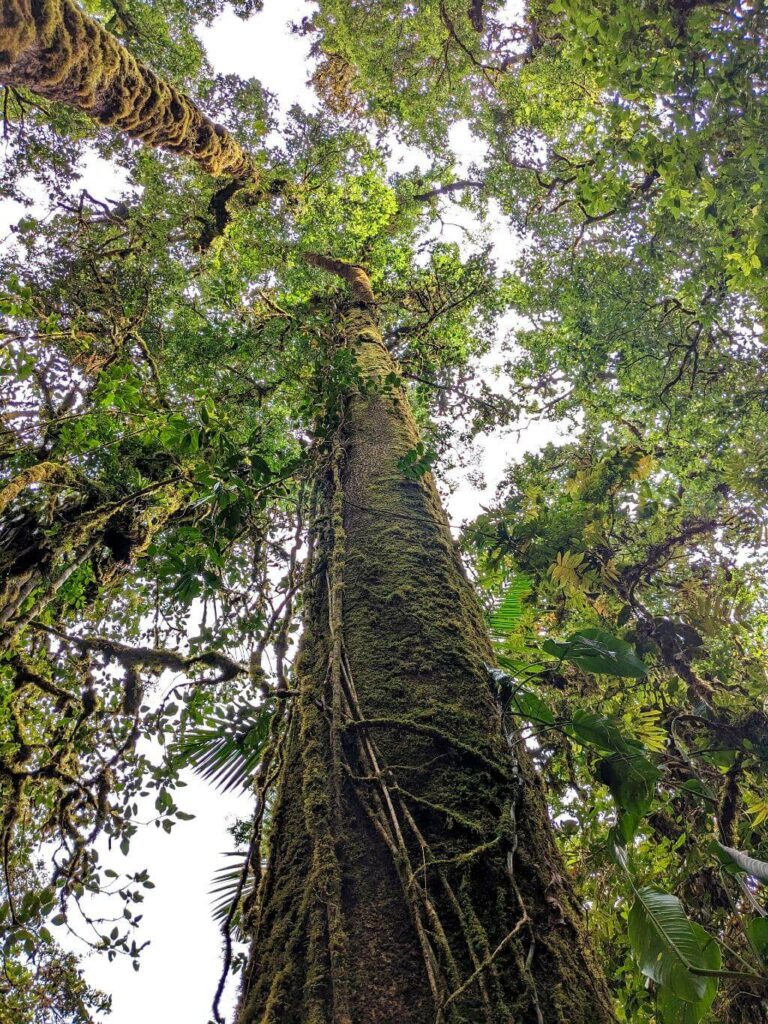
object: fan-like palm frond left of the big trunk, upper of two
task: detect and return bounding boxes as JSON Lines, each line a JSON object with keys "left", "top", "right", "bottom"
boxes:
{"left": 177, "top": 705, "right": 272, "bottom": 792}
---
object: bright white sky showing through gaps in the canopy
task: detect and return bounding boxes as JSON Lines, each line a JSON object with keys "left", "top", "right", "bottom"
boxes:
{"left": 0, "top": 0, "right": 573, "bottom": 1024}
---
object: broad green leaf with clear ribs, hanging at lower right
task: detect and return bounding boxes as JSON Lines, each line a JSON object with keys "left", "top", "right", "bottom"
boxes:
{"left": 628, "top": 886, "right": 721, "bottom": 1003}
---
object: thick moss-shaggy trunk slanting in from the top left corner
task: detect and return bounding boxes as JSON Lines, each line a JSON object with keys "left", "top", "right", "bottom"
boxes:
{"left": 0, "top": 0, "right": 254, "bottom": 179}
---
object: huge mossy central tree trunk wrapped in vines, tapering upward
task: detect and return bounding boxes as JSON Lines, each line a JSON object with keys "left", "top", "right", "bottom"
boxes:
{"left": 239, "top": 257, "right": 614, "bottom": 1024}
